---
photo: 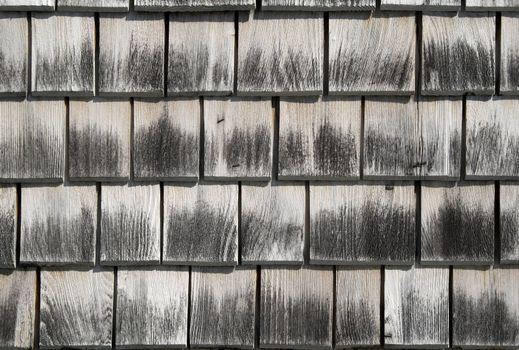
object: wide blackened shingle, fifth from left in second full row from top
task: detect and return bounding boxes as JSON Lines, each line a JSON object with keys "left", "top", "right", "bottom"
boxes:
{"left": 278, "top": 97, "right": 362, "bottom": 180}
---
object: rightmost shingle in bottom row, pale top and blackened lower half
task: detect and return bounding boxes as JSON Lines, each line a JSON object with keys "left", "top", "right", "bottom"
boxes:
{"left": 452, "top": 267, "right": 519, "bottom": 348}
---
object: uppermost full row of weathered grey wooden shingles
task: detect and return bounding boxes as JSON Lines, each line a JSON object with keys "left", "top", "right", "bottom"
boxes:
{"left": 0, "top": 12, "right": 519, "bottom": 97}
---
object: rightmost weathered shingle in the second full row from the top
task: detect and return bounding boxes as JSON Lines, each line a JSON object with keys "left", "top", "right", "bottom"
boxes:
{"left": 466, "top": 97, "right": 519, "bottom": 179}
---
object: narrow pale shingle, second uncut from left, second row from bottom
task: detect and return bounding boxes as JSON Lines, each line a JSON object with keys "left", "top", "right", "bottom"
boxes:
{"left": 101, "top": 184, "right": 160, "bottom": 265}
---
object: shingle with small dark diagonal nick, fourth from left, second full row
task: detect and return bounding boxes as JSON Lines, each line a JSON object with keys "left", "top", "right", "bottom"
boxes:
{"left": 204, "top": 98, "right": 274, "bottom": 180}
